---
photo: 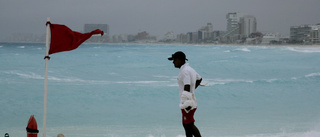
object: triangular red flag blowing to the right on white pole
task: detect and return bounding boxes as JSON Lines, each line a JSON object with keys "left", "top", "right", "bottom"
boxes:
{"left": 49, "top": 23, "right": 103, "bottom": 54}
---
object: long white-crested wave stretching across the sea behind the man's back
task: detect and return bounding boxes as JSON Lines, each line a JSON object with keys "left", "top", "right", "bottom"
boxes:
{"left": 5, "top": 71, "right": 320, "bottom": 87}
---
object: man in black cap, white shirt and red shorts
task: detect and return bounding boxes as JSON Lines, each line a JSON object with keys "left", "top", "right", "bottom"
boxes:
{"left": 168, "top": 51, "right": 202, "bottom": 137}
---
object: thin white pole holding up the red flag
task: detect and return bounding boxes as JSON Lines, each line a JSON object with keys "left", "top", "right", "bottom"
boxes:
{"left": 43, "top": 17, "right": 50, "bottom": 137}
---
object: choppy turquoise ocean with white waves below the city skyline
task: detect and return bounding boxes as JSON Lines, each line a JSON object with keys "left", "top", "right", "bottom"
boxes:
{"left": 0, "top": 43, "right": 320, "bottom": 137}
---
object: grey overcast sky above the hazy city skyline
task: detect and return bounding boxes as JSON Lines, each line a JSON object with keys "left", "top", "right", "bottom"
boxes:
{"left": 0, "top": 0, "right": 320, "bottom": 40}
